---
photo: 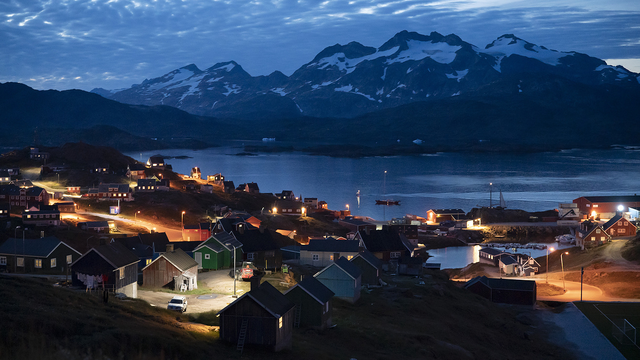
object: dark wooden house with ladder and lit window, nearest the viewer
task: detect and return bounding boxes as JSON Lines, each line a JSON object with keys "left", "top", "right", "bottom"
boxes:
{"left": 218, "top": 282, "right": 295, "bottom": 351}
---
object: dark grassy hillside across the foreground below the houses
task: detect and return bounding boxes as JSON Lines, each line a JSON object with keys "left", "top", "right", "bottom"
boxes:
{"left": 0, "top": 274, "right": 575, "bottom": 360}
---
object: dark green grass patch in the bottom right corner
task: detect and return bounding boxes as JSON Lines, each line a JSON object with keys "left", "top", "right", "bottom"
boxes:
{"left": 575, "top": 302, "right": 640, "bottom": 359}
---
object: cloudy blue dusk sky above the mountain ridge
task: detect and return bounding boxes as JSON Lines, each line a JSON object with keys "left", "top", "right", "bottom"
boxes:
{"left": 0, "top": 0, "right": 640, "bottom": 90}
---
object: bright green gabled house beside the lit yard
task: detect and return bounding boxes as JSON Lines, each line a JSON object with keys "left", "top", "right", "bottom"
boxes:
{"left": 193, "top": 232, "right": 242, "bottom": 270}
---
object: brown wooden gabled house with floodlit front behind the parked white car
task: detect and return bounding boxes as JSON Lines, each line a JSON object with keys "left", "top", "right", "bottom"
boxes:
{"left": 142, "top": 244, "right": 198, "bottom": 291}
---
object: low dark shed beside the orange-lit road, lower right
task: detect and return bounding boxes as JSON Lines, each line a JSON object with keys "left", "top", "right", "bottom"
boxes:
{"left": 464, "top": 276, "right": 537, "bottom": 305}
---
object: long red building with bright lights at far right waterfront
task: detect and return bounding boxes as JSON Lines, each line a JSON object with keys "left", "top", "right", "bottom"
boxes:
{"left": 573, "top": 195, "right": 640, "bottom": 220}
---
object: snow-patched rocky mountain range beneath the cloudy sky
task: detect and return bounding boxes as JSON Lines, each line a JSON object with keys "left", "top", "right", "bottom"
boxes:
{"left": 93, "top": 31, "right": 640, "bottom": 118}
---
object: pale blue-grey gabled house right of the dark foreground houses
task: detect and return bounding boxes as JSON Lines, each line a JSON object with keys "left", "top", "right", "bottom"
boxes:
{"left": 313, "top": 257, "right": 362, "bottom": 303}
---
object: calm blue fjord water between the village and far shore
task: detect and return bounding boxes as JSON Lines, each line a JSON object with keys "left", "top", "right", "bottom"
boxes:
{"left": 127, "top": 147, "right": 640, "bottom": 220}
